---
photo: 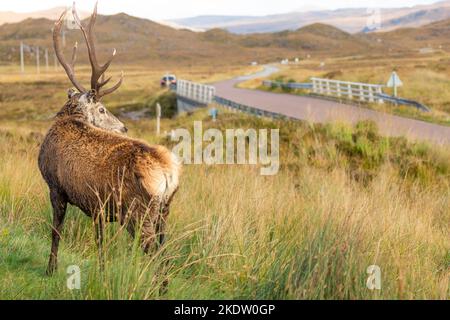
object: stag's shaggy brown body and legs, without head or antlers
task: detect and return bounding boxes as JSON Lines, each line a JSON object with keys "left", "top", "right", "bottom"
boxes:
{"left": 39, "top": 100, "right": 180, "bottom": 274}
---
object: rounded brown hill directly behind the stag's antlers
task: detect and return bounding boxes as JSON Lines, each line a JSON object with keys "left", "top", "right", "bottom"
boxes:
{"left": 0, "top": 14, "right": 260, "bottom": 67}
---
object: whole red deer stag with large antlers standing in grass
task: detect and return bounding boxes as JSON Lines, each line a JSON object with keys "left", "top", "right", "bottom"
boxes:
{"left": 39, "top": 5, "right": 181, "bottom": 275}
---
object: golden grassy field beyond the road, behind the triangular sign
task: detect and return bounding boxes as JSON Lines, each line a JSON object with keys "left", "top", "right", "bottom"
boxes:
{"left": 241, "top": 52, "right": 450, "bottom": 125}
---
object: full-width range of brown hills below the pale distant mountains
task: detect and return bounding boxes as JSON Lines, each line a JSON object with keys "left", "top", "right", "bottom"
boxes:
{"left": 0, "top": 13, "right": 450, "bottom": 65}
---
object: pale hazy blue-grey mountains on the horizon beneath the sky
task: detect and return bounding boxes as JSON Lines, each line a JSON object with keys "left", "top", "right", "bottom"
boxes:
{"left": 173, "top": 0, "right": 450, "bottom": 34}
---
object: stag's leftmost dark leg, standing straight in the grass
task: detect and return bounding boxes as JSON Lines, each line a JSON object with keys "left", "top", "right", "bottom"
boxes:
{"left": 47, "top": 190, "right": 67, "bottom": 275}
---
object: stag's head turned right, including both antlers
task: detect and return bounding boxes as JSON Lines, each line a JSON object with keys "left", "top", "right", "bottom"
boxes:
{"left": 53, "top": 3, "right": 128, "bottom": 133}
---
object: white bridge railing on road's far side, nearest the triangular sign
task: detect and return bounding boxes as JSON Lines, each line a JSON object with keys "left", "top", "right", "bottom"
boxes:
{"left": 311, "top": 78, "right": 383, "bottom": 103}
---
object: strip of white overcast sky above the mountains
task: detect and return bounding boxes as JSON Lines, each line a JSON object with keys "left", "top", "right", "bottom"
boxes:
{"left": 0, "top": 0, "right": 438, "bottom": 20}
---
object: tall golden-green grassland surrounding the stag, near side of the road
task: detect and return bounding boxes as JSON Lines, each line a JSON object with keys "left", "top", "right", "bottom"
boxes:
{"left": 0, "top": 63, "right": 450, "bottom": 299}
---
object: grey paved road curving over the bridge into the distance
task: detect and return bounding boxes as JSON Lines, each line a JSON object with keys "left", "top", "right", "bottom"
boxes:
{"left": 214, "top": 66, "right": 450, "bottom": 145}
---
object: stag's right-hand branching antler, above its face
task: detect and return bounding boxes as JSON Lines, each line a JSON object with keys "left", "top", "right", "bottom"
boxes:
{"left": 72, "top": 2, "right": 123, "bottom": 98}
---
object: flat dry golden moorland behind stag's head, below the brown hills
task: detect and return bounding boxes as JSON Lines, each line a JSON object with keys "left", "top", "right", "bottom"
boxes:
{"left": 0, "top": 65, "right": 258, "bottom": 122}
